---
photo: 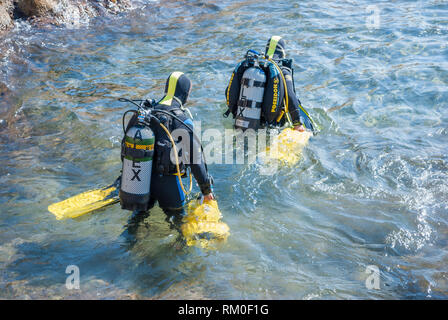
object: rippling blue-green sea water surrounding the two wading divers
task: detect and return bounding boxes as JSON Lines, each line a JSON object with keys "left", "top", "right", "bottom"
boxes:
{"left": 0, "top": 0, "right": 448, "bottom": 299}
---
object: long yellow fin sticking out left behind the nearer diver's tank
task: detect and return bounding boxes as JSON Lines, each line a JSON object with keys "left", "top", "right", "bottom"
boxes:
{"left": 48, "top": 183, "right": 120, "bottom": 220}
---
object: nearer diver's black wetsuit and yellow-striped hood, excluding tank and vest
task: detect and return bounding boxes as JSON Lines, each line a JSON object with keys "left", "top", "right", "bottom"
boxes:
{"left": 122, "top": 72, "right": 214, "bottom": 233}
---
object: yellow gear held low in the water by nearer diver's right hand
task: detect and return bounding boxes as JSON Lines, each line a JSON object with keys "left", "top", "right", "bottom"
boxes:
{"left": 181, "top": 199, "right": 230, "bottom": 249}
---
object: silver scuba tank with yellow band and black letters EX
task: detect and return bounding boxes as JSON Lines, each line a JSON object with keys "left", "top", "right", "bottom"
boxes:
{"left": 119, "top": 124, "right": 155, "bottom": 211}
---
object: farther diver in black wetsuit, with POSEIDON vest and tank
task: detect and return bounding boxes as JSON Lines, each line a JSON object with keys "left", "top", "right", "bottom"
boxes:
{"left": 224, "top": 36, "right": 315, "bottom": 131}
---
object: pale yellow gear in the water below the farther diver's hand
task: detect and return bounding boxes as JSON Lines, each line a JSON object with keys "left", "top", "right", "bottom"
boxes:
{"left": 265, "top": 128, "right": 313, "bottom": 165}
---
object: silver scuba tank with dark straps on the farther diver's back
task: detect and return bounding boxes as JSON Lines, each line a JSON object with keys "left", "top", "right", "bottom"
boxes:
{"left": 235, "top": 67, "right": 266, "bottom": 131}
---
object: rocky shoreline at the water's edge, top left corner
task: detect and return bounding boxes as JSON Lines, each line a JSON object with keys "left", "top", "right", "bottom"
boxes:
{"left": 0, "top": 0, "right": 132, "bottom": 34}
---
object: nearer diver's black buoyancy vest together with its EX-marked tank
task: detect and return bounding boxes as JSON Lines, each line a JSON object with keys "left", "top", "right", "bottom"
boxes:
{"left": 119, "top": 100, "right": 191, "bottom": 211}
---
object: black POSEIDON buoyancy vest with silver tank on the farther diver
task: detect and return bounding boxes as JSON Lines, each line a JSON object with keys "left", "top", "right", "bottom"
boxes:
{"left": 224, "top": 50, "right": 285, "bottom": 130}
